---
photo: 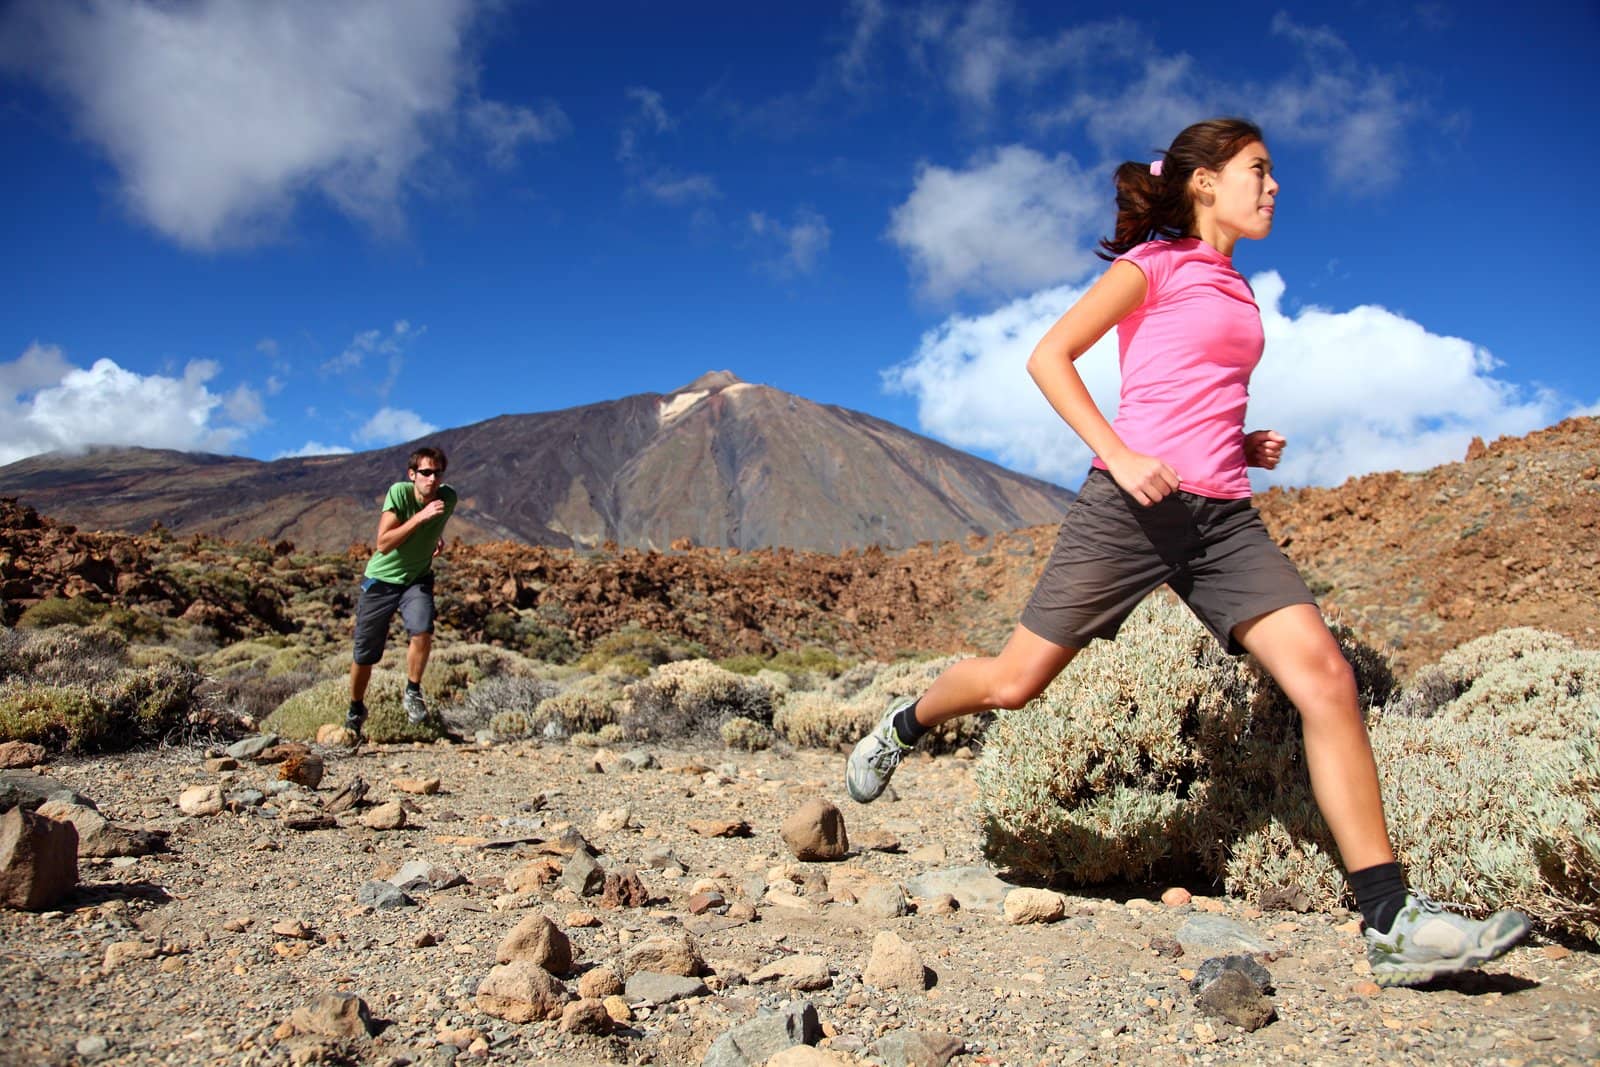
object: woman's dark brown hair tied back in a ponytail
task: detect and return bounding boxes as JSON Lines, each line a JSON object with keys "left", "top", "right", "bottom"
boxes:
{"left": 1098, "top": 118, "right": 1262, "bottom": 259}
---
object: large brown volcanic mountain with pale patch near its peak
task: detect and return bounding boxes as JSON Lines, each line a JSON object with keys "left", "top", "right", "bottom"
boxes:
{"left": 0, "top": 371, "right": 1072, "bottom": 552}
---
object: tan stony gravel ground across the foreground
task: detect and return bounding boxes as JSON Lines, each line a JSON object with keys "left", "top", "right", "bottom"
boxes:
{"left": 0, "top": 742, "right": 1600, "bottom": 1067}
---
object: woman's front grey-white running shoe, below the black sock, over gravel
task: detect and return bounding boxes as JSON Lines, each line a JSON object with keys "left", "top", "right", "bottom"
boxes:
{"left": 1366, "top": 893, "right": 1528, "bottom": 985}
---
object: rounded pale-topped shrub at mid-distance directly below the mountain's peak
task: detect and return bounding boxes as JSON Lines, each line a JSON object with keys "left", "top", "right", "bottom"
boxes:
{"left": 619, "top": 659, "right": 776, "bottom": 737}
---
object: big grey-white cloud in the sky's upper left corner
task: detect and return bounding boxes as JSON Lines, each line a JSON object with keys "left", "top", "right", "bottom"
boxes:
{"left": 0, "top": 0, "right": 565, "bottom": 250}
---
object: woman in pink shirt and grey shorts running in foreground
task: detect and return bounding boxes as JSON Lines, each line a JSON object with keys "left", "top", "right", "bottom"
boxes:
{"left": 845, "top": 118, "right": 1528, "bottom": 985}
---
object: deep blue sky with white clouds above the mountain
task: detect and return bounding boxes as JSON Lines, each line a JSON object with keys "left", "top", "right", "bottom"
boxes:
{"left": 0, "top": 0, "right": 1600, "bottom": 485}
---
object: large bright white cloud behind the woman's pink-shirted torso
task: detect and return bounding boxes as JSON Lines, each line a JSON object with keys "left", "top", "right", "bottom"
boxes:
{"left": 885, "top": 272, "right": 1574, "bottom": 488}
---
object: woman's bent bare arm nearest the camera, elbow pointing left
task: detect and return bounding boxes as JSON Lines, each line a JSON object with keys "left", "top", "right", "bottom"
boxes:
{"left": 1027, "top": 261, "right": 1178, "bottom": 507}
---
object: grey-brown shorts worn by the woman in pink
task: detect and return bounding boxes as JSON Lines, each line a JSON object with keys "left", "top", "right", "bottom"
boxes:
{"left": 1022, "top": 467, "right": 1317, "bottom": 656}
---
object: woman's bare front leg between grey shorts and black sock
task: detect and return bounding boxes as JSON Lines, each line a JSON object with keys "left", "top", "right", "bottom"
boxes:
{"left": 1234, "top": 605, "right": 1394, "bottom": 870}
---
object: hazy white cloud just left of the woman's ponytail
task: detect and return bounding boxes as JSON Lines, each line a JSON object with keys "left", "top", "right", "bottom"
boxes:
{"left": 890, "top": 146, "right": 1106, "bottom": 299}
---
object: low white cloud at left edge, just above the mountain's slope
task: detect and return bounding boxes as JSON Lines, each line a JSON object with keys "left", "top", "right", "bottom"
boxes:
{"left": 0, "top": 344, "right": 252, "bottom": 464}
